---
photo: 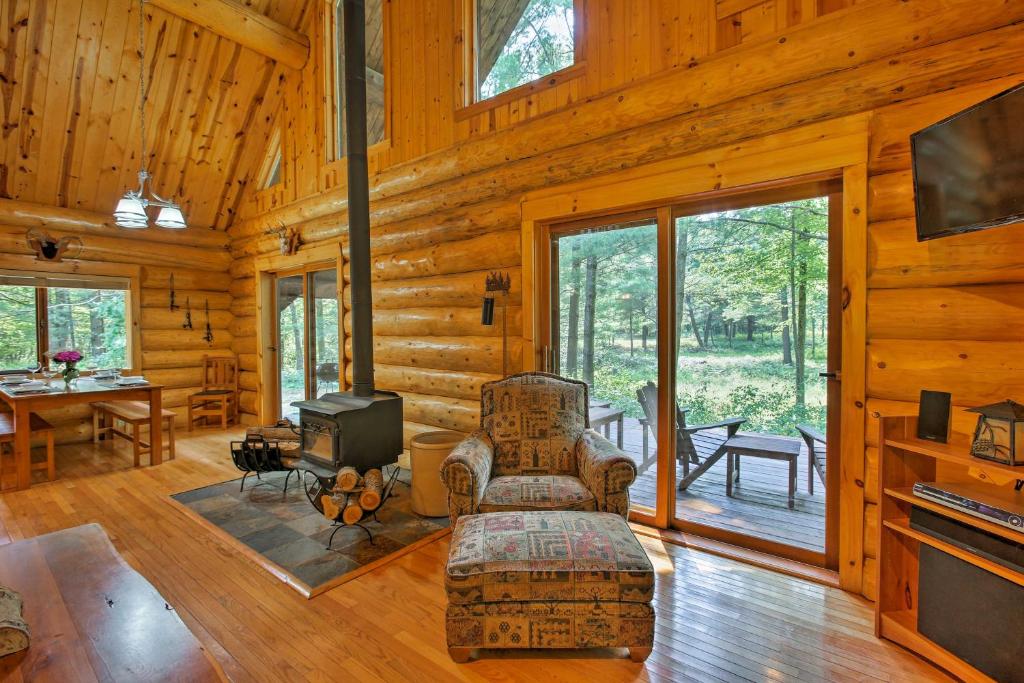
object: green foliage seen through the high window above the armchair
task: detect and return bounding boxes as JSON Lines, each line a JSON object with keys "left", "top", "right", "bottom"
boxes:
{"left": 479, "top": 0, "right": 574, "bottom": 99}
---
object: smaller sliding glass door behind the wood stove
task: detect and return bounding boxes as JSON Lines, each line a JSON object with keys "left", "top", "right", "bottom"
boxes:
{"left": 273, "top": 266, "right": 342, "bottom": 420}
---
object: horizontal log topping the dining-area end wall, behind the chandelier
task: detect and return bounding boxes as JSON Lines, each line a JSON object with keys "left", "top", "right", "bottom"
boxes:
{"left": 0, "top": 199, "right": 228, "bottom": 250}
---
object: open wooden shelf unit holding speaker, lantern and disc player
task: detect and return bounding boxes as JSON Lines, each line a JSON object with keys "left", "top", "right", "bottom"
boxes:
{"left": 874, "top": 417, "right": 1024, "bottom": 681}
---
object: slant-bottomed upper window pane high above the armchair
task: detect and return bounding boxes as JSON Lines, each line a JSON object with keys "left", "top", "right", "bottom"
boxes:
{"left": 475, "top": 0, "right": 575, "bottom": 100}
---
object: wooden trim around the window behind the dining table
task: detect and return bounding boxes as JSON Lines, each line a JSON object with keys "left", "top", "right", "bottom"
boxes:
{"left": 0, "top": 256, "right": 142, "bottom": 374}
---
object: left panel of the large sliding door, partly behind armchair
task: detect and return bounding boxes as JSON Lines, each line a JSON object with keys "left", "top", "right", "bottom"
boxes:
{"left": 549, "top": 214, "right": 658, "bottom": 513}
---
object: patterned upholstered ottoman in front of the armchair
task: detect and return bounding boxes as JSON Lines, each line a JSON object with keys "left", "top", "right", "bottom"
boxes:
{"left": 444, "top": 511, "right": 654, "bottom": 663}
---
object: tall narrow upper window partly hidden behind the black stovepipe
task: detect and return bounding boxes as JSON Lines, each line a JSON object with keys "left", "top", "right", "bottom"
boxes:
{"left": 335, "top": 0, "right": 387, "bottom": 159}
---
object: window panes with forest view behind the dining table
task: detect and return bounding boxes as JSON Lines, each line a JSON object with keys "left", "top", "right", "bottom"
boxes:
{"left": 0, "top": 285, "right": 130, "bottom": 370}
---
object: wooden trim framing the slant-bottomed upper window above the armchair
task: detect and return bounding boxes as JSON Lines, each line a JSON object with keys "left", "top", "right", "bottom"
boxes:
{"left": 455, "top": 0, "right": 587, "bottom": 114}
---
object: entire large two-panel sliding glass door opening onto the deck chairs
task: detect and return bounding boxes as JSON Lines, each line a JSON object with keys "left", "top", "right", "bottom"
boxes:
{"left": 539, "top": 181, "right": 842, "bottom": 566}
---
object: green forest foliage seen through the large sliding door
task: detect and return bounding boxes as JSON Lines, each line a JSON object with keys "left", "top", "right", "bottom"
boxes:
{"left": 558, "top": 198, "right": 828, "bottom": 435}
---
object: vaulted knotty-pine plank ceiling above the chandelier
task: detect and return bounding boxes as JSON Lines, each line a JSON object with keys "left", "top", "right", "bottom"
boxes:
{"left": 0, "top": 0, "right": 311, "bottom": 228}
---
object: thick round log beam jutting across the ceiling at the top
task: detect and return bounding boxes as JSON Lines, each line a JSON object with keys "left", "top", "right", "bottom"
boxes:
{"left": 148, "top": 0, "right": 309, "bottom": 69}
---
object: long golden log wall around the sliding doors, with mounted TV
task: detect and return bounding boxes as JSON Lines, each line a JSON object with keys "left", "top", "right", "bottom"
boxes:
{"left": 222, "top": 0, "right": 1024, "bottom": 597}
